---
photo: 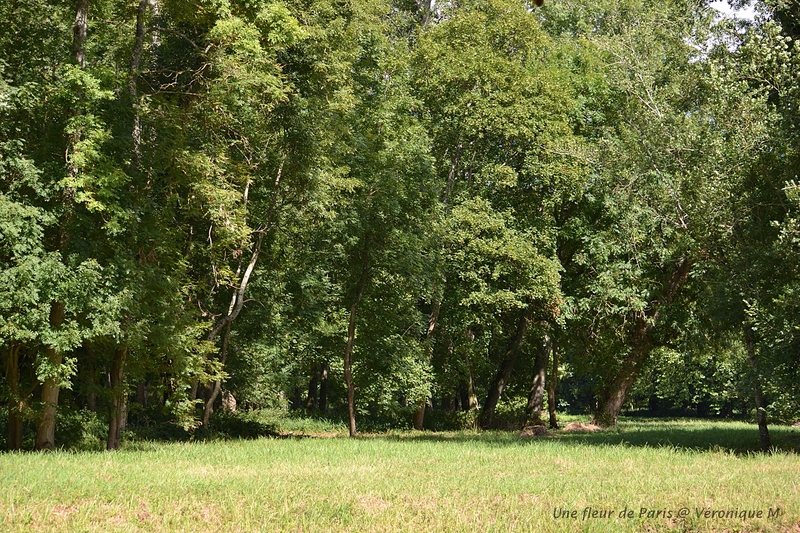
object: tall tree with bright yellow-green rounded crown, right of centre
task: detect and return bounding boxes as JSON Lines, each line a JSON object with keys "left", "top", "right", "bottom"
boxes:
{"left": 415, "top": 1, "right": 575, "bottom": 425}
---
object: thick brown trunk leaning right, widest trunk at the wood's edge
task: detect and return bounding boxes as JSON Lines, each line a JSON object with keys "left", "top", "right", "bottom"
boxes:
{"left": 592, "top": 257, "right": 692, "bottom": 427}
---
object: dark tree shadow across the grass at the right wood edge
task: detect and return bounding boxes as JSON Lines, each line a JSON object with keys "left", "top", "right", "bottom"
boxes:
{"left": 375, "top": 419, "right": 800, "bottom": 455}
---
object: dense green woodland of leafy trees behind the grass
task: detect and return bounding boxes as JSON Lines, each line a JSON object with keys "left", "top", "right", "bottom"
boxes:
{"left": 0, "top": 0, "right": 800, "bottom": 450}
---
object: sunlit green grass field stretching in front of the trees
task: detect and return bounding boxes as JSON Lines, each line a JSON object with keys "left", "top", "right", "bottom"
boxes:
{"left": 0, "top": 420, "right": 800, "bottom": 533}
